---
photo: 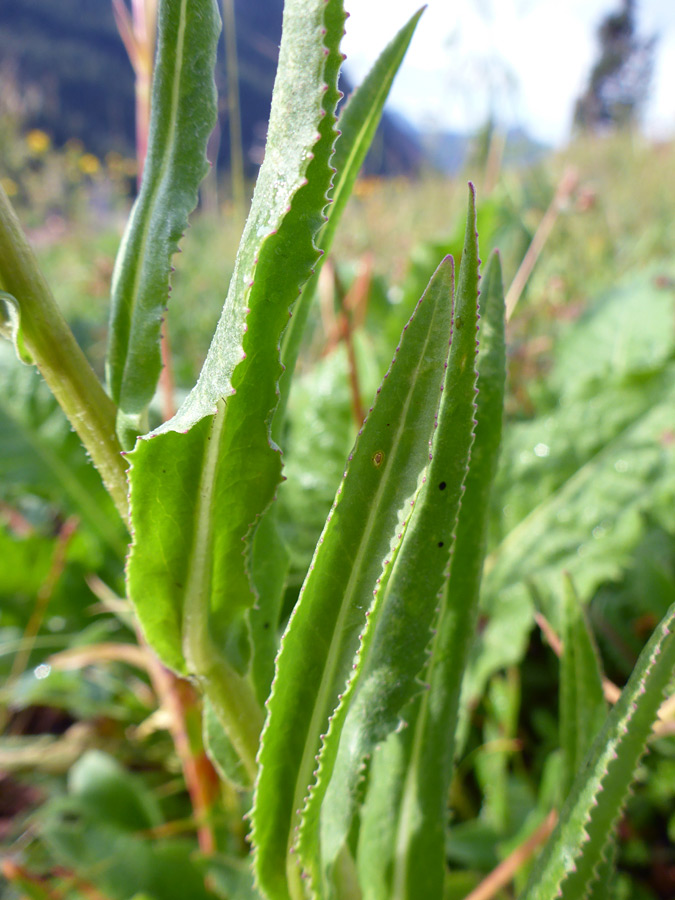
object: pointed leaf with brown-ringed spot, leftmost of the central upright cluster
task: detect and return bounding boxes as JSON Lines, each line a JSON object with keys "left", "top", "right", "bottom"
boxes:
{"left": 253, "top": 260, "right": 460, "bottom": 900}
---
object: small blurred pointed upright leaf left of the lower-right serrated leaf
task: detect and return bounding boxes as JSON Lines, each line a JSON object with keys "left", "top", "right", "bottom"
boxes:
{"left": 560, "top": 576, "right": 607, "bottom": 798}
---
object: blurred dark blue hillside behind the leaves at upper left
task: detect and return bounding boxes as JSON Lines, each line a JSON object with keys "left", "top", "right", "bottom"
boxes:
{"left": 0, "top": 0, "right": 421, "bottom": 174}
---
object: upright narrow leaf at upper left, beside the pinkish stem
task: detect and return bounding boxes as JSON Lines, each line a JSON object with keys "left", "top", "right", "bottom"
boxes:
{"left": 106, "top": 0, "right": 220, "bottom": 446}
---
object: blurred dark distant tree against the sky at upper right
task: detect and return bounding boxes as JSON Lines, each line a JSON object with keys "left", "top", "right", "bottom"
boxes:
{"left": 574, "top": 0, "right": 656, "bottom": 131}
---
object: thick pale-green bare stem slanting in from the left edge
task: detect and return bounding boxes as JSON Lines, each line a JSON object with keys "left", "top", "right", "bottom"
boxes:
{"left": 0, "top": 187, "right": 129, "bottom": 526}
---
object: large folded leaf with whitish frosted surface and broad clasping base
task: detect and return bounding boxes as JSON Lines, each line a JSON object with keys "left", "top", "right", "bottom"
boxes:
{"left": 128, "top": 0, "right": 344, "bottom": 775}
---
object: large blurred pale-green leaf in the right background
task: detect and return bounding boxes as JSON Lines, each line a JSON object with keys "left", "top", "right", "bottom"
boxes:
{"left": 466, "top": 269, "right": 675, "bottom": 712}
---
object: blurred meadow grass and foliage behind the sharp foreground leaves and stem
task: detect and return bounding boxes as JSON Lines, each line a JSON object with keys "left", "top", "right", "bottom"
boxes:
{"left": 0, "top": 0, "right": 675, "bottom": 900}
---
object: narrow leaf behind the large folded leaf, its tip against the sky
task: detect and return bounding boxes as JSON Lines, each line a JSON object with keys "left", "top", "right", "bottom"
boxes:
{"left": 276, "top": 7, "right": 426, "bottom": 408}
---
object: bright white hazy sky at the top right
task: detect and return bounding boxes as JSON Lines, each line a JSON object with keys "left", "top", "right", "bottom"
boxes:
{"left": 343, "top": 0, "right": 675, "bottom": 145}
